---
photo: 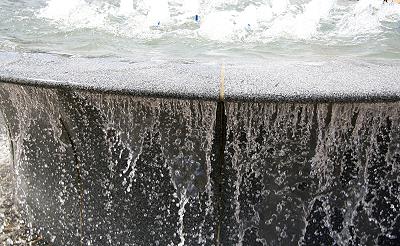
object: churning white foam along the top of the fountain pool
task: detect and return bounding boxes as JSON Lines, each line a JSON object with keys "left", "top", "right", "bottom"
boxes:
{"left": 38, "top": 0, "right": 400, "bottom": 43}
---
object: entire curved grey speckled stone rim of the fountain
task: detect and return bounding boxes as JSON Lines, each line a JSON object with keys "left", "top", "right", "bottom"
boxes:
{"left": 0, "top": 52, "right": 400, "bottom": 102}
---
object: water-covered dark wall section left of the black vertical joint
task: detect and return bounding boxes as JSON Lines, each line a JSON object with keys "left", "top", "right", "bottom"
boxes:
{"left": 1, "top": 85, "right": 216, "bottom": 245}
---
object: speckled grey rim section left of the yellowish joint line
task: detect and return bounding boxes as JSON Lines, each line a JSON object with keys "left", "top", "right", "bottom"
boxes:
{"left": 0, "top": 52, "right": 220, "bottom": 99}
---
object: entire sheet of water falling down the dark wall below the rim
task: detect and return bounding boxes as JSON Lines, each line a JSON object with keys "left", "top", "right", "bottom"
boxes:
{"left": 0, "top": 84, "right": 400, "bottom": 245}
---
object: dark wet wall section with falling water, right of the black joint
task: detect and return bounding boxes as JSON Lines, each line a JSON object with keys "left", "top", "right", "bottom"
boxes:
{"left": 224, "top": 103, "right": 400, "bottom": 245}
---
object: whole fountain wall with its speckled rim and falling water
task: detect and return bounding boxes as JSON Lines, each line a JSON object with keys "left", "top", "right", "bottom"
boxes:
{"left": 0, "top": 52, "right": 400, "bottom": 245}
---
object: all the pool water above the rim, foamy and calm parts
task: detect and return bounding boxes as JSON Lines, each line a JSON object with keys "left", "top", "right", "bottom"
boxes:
{"left": 0, "top": 0, "right": 400, "bottom": 59}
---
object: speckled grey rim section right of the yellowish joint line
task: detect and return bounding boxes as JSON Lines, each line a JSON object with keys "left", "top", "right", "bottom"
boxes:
{"left": 225, "top": 59, "right": 400, "bottom": 102}
